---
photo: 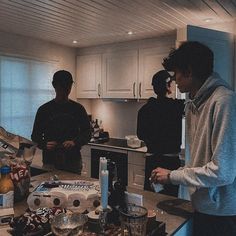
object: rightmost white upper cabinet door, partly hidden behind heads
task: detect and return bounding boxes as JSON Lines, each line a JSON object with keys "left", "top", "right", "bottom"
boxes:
{"left": 138, "top": 47, "right": 170, "bottom": 98}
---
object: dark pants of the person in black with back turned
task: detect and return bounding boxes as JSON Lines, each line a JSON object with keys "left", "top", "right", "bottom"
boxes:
{"left": 144, "top": 154, "right": 180, "bottom": 197}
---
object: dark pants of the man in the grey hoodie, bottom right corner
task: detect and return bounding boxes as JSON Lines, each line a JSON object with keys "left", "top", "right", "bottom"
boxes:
{"left": 193, "top": 212, "right": 236, "bottom": 236}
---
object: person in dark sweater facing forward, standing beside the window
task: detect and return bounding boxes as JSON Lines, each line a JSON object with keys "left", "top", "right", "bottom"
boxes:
{"left": 31, "top": 70, "right": 90, "bottom": 174}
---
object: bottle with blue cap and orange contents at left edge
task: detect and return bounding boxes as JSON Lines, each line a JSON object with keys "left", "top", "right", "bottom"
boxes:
{"left": 0, "top": 166, "right": 14, "bottom": 208}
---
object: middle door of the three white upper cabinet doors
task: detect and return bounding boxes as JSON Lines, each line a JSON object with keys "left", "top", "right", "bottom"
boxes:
{"left": 102, "top": 50, "right": 138, "bottom": 98}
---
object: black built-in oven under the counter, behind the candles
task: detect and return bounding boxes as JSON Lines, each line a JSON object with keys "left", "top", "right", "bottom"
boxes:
{"left": 91, "top": 147, "right": 128, "bottom": 186}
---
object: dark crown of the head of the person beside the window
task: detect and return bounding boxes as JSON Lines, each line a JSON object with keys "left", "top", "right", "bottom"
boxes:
{"left": 52, "top": 70, "right": 74, "bottom": 88}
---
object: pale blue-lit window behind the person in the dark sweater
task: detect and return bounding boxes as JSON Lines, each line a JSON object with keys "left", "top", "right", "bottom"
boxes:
{"left": 0, "top": 56, "right": 55, "bottom": 139}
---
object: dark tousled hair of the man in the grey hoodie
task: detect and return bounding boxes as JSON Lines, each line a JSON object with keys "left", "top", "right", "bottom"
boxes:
{"left": 162, "top": 41, "right": 214, "bottom": 82}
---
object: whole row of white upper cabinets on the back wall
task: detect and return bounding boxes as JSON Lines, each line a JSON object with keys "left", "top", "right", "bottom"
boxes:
{"left": 77, "top": 34, "right": 176, "bottom": 99}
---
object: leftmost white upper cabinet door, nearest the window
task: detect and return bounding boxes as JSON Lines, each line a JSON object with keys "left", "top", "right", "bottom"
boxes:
{"left": 76, "top": 54, "right": 102, "bottom": 98}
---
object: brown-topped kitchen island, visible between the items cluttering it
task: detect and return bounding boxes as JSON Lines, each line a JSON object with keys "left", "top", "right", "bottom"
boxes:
{"left": 0, "top": 170, "right": 193, "bottom": 236}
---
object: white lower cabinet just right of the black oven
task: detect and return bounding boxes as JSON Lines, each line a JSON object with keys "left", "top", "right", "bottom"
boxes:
{"left": 128, "top": 151, "right": 145, "bottom": 190}
